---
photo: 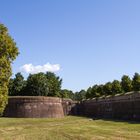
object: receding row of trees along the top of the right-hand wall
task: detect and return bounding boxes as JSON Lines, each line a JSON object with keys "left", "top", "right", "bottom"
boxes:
{"left": 85, "top": 73, "right": 140, "bottom": 99}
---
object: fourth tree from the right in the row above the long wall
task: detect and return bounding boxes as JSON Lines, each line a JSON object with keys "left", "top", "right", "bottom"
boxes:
{"left": 103, "top": 82, "right": 112, "bottom": 95}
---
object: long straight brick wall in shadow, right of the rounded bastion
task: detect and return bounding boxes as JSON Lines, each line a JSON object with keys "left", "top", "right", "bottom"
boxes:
{"left": 80, "top": 92, "right": 140, "bottom": 120}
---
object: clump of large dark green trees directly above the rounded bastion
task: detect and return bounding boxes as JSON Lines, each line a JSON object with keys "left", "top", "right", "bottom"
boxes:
{"left": 9, "top": 72, "right": 62, "bottom": 97}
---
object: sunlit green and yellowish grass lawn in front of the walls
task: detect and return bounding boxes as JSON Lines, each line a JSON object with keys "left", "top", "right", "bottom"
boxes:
{"left": 0, "top": 116, "right": 140, "bottom": 140}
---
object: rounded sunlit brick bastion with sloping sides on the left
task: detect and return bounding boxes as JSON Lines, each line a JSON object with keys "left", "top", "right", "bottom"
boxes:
{"left": 4, "top": 96, "right": 64, "bottom": 118}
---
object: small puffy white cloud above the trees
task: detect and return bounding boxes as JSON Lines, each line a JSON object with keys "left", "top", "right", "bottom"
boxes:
{"left": 20, "top": 63, "right": 60, "bottom": 74}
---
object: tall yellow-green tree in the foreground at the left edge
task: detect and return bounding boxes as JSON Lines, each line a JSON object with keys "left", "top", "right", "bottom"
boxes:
{"left": 0, "top": 24, "right": 18, "bottom": 114}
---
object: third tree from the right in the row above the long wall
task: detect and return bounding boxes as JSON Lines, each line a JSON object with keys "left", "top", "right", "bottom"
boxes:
{"left": 112, "top": 80, "right": 122, "bottom": 95}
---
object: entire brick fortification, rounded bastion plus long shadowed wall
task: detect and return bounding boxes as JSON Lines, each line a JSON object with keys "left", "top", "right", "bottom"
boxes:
{"left": 4, "top": 92, "right": 140, "bottom": 121}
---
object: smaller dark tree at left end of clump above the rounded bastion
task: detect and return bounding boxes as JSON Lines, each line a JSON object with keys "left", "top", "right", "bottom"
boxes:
{"left": 9, "top": 72, "right": 26, "bottom": 96}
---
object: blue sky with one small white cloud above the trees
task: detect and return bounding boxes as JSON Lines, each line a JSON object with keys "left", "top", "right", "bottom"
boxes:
{"left": 0, "top": 0, "right": 140, "bottom": 91}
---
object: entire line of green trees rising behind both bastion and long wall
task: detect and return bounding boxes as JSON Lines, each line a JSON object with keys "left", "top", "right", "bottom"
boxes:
{"left": 9, "top": 72, "right": 140, "bottom": 101}
